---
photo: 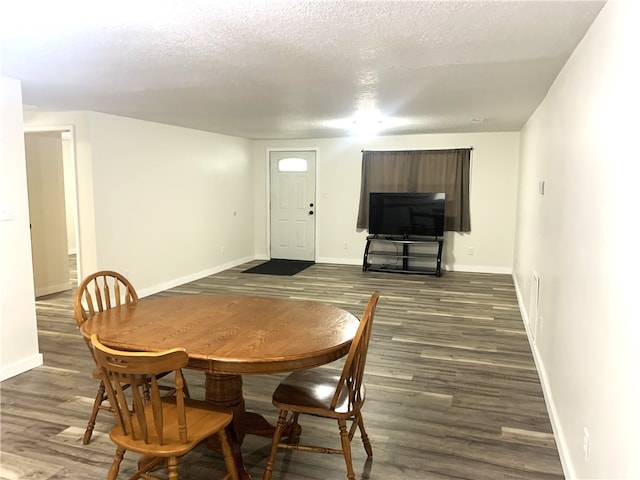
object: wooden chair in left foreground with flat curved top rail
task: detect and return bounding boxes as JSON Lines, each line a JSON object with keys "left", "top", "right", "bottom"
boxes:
{"left": 91, "top": 334, "right": 238, "bottom": 480}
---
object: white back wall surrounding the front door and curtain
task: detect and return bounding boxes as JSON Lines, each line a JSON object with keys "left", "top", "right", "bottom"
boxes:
{"left": 253, "top": 132, "right": 520, "bottom": 273}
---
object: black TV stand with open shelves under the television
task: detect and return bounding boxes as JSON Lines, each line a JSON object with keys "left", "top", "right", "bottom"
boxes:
{"left": 362, "top": 235, "right": 444, "bottom": 277}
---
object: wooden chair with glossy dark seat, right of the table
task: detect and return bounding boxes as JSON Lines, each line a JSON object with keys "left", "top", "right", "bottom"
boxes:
{"left": 263, "top": 292, "right": 379, "bottom": 480}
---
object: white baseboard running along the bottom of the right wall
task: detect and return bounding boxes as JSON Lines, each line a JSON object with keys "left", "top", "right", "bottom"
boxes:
{"left": 512, "top": 273, "right": 576, "bottom": 480}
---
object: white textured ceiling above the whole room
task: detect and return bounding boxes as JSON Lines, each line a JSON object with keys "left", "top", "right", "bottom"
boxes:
{"left": 0, "top": 0, "right": 604, "bottom": 139}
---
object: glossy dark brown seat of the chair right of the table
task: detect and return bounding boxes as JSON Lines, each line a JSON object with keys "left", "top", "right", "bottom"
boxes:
{"left": 273, "top": 368, "right": 365, "bottom": 418}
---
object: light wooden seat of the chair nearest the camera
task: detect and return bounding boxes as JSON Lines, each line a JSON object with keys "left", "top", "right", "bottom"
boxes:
{"left": 109, "top": 397, "right": 233, "bottom": 457}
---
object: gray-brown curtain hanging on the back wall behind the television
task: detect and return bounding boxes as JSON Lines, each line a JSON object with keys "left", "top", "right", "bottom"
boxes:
{"left": 356, "top": 148, "right": 471, "bottom": 232}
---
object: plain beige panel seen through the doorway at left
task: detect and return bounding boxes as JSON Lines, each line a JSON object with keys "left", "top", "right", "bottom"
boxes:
{"left": 24, "top": 132, "right": 71, "bottom": 297}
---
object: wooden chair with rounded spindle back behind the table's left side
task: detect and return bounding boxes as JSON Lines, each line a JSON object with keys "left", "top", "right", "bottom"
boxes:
{"left": 73, "top": 270, "right": 189, "bottom": 445}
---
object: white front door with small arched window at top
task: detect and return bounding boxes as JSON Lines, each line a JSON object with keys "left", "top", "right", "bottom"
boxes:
{"left": 269, "top": 151, "right": 316, "bottom": 261}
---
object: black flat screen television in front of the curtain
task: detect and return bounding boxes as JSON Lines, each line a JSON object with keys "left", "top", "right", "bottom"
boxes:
{"left": 369, "top": 192, "right": 444, "bottom": 238}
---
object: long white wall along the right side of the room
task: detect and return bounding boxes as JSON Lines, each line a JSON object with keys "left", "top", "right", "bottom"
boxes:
{"left": 514, "top": 1, "right": 640, "bottom": 479}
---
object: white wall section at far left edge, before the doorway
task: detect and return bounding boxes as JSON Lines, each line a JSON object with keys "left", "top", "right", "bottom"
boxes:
{"left": 0, "top": 77, "right": 42, "bottom": 381}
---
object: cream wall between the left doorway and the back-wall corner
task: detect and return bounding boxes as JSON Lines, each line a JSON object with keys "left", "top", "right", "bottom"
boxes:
{"left": 26, "top": 112, "right": 254, "bottom": 296}
